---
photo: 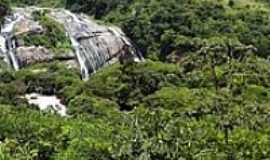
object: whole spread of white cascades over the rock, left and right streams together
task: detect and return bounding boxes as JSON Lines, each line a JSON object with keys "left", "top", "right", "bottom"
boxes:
{"left": 0, "top": 7, "right": 143, "bottom": 80}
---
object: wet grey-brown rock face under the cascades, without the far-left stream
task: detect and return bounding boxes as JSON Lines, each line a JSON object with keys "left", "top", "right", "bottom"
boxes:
{"left": 0, "top": 7, "right": 143, "bottom": 79}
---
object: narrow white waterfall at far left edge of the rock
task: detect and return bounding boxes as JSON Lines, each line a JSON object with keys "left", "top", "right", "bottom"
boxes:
{"left": 0, "top": 14, "right": 21, "bottom": 71}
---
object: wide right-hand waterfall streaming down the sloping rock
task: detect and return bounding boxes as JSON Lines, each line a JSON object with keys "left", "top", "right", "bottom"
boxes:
{"left": 50, "top": 10, "right": 142, "bottom": 79}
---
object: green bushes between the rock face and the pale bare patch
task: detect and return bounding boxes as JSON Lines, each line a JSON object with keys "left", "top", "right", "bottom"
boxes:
{"left": 15, "top": 62, "right": 81, "bottom": 94}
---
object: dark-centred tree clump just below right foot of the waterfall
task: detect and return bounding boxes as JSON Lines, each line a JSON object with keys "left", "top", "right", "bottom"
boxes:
{"left": 86, "top": 61, "right": 180, "bottom": 110}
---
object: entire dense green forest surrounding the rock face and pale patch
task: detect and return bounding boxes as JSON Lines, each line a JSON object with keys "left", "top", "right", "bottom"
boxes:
{"left": 0, "top": 0, "right": 270, "bottom": 160}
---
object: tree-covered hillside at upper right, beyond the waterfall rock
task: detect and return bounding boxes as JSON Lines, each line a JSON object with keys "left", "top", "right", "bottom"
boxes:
{"left": 102, "top": 0, "right": 270, "bottom": 59}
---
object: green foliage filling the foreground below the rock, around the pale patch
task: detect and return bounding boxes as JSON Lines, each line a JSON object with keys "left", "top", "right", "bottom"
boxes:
{"left": 0, "top": 51, "right": 270, "bottom": 160}
